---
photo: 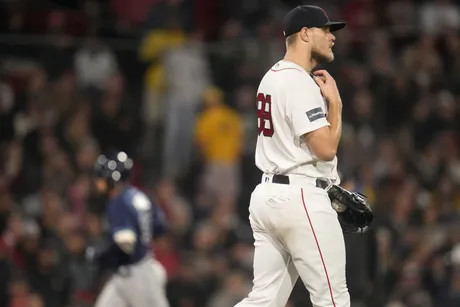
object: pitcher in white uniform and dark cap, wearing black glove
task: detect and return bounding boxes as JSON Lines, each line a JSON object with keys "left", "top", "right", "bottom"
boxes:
{"left": 236, "top": 5, "right": 372, "bottom": 307}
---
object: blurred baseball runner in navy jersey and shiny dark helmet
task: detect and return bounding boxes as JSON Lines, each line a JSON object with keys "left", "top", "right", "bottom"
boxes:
{"left": 86, "top": 152, "right": 169, "bottom": 307}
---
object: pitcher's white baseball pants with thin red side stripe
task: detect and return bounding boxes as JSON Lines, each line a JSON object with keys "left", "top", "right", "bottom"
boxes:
{"left": 235, "top": 174, "right": 350, "bottom": 307}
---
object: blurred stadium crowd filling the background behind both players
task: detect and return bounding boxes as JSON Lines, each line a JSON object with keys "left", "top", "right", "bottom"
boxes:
{"left": 0, "top": 0, "right": 460, "bottom": 307}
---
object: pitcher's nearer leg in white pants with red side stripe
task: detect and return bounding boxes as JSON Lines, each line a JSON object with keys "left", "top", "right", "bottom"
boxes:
{"left": 284, "top": 187, "right": 350, "bottom": 307}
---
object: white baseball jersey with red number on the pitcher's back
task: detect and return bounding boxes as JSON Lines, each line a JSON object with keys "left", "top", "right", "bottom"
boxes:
{"left": 255, "top": 60, "right": 340, "bottom": 184}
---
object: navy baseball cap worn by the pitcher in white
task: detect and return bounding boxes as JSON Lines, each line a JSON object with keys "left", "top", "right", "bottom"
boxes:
{"left": 283, "top": 5, "right": 346, "bottom": 37}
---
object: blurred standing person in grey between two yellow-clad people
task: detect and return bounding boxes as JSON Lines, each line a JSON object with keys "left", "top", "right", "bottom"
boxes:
{"left": 163, "top": 30, "right": 210, "bottom": 178}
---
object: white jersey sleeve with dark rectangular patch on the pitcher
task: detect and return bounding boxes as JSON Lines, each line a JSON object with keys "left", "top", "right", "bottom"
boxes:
{"left": 287, "top": 78, "right": 330, "bottom": 138}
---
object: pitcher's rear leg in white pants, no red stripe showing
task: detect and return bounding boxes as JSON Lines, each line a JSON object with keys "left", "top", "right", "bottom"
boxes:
{"left": 235, "top": 186, "right": 299, "bottom": 307}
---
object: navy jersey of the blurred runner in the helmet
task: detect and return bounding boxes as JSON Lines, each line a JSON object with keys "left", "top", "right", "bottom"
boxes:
{"left": 101, "top": 186, "right": 165, "bottom": 266}
